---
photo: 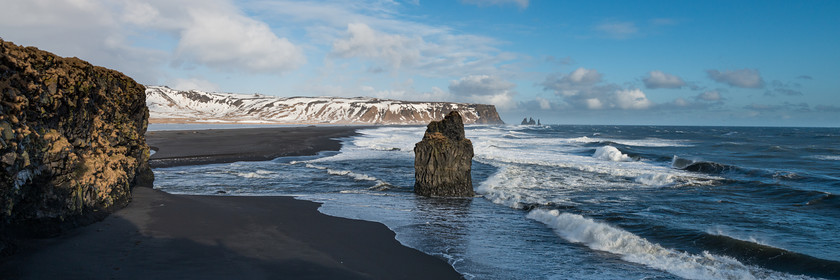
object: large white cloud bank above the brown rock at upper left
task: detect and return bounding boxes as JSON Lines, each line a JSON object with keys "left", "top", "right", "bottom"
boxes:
{"left": 0, "top": 0, "right": 305, "bottom": 83}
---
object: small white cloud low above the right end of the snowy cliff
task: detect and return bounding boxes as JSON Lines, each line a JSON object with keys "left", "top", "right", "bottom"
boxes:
{"left": 449, "top": 75, "right": 516, "bottom": 110}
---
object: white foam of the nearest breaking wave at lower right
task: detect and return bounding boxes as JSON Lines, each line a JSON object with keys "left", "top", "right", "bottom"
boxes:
{"left": 527, "top": 209, "right": 810, "bottom": 279}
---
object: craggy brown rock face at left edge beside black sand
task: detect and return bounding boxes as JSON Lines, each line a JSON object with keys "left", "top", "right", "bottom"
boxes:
{"left": 0, "top": 40, "right": 154, "bottom": 236}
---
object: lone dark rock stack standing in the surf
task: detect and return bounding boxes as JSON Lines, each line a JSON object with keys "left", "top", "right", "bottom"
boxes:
{"left": 414, "top": 111, "right": 475, "bottom": 197}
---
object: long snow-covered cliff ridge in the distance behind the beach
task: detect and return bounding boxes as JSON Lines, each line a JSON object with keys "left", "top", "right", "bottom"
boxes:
{"left": 146, "top": 86, "right": 504, "bottom": 124}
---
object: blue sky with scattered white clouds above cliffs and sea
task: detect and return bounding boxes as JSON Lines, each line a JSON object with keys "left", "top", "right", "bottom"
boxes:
{"left": 0, "top": 0, "right": 840, "bottom": 124}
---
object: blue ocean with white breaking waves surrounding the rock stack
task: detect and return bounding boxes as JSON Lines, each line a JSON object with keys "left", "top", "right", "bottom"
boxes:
{"left": 154, "top": 125, "right": 840, "bottom": 279}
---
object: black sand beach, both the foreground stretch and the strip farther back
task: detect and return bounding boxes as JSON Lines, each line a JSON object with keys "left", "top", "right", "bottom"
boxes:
{"left": 0, "top": 127, "right": 462, "bottom": 279}
